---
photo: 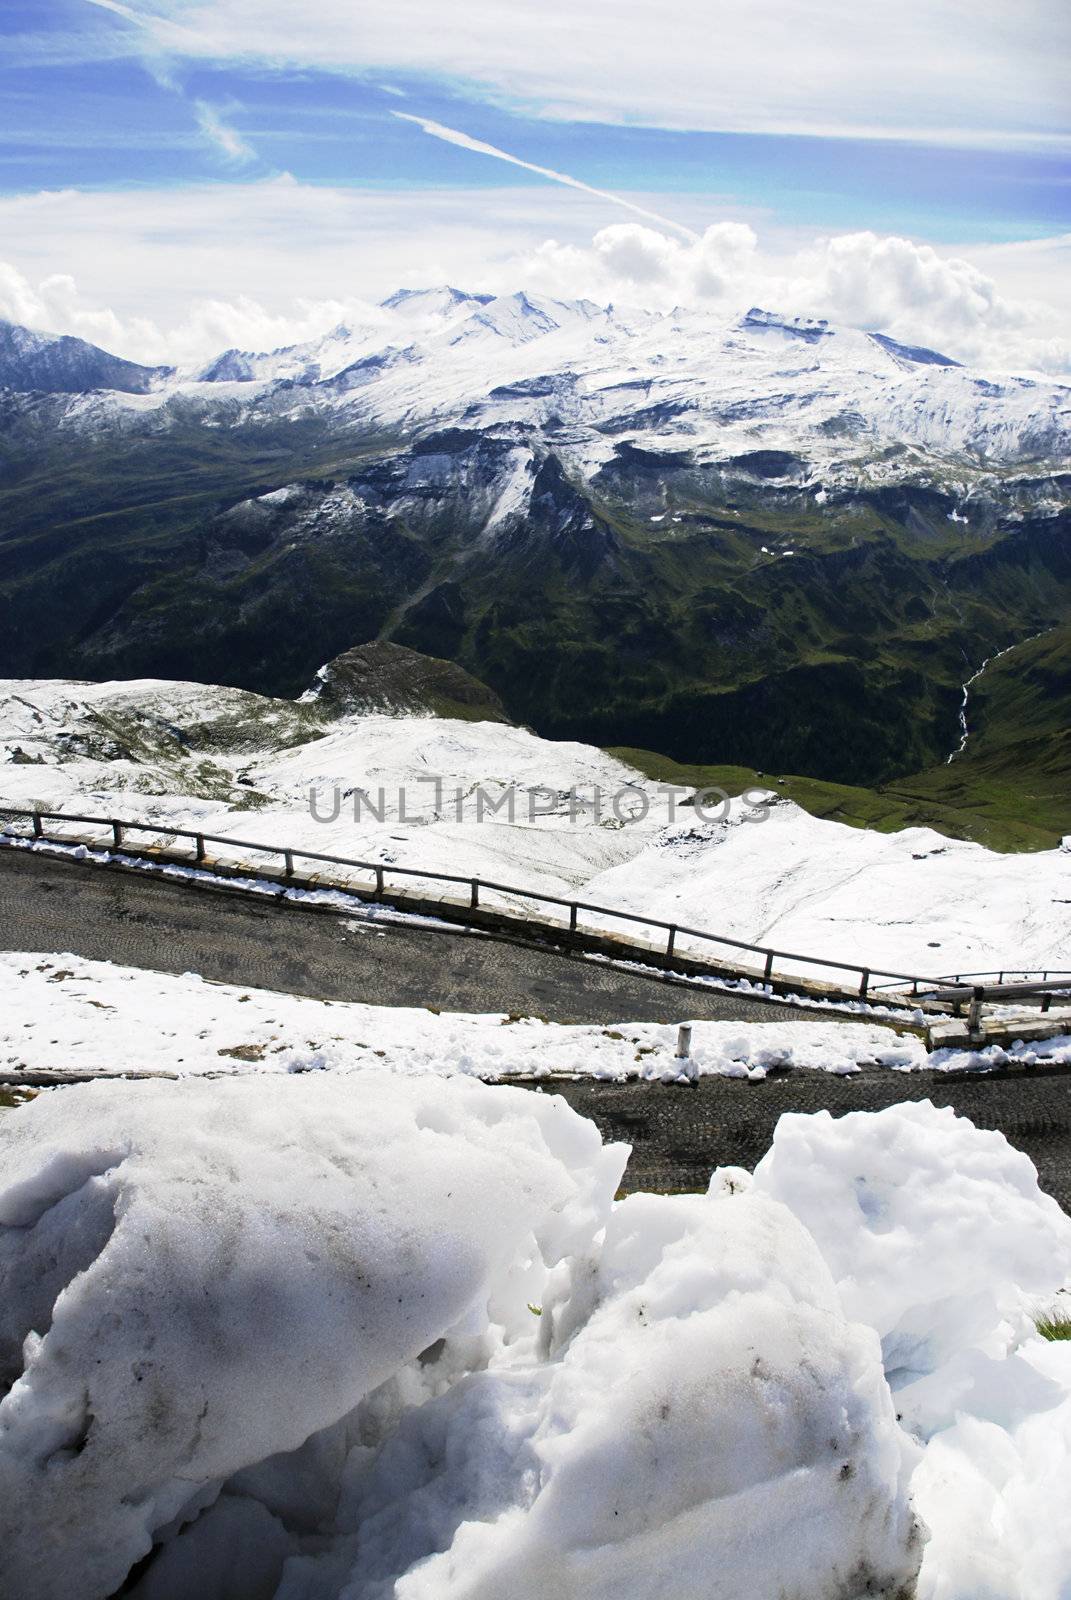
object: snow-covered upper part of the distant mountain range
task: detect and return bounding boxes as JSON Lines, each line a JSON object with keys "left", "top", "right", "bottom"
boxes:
{"left": 0, "top": 288, "right": 1071, "bottom": 482}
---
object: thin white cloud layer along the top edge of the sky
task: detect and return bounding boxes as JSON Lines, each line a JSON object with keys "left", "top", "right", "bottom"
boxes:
{"left": 83, "top": 0, "right": 1069, "bottom": 147}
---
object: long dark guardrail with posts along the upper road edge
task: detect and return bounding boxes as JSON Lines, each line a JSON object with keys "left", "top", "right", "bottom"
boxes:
{"left": 0, "top": 803, "right": 1071, "bottom": 1008}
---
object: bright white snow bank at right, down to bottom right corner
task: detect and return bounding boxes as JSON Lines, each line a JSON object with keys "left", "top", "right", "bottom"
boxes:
{"left": 754, "top": 1102, "right": 1071, "bottom": 1600}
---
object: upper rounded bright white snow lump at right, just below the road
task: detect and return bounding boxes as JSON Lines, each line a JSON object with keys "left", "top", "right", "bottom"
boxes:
{"left": 754, "top": 1101, "right": 1071, "bottom": 1430}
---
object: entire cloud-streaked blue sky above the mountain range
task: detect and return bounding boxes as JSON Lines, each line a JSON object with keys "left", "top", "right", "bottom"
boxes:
{"left": 0, "top": 0, "right": 1071, "bottom": 366}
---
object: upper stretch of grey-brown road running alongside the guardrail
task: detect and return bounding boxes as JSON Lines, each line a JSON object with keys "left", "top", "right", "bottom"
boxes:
{"left": 0, "top": 850, "right": 815, "bottom": 1022}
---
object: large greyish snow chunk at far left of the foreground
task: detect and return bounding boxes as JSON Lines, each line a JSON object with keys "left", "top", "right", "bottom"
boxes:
{"left": 0, "top": 1074, "right": 626, "bottom": 1600}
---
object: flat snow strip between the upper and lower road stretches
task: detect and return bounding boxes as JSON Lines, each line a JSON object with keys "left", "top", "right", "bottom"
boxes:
{"left": 0, "top": 947, "right": 1071, "bottom": 1080}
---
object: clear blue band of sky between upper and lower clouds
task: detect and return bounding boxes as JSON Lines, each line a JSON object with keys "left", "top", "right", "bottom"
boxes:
{"left": 0, "top": 0, "right": 1071, "bottom": 243}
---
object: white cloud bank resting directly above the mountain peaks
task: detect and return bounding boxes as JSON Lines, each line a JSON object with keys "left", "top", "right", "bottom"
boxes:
{"left": 0, "top": 178, "right": 1071, "bottom": 373}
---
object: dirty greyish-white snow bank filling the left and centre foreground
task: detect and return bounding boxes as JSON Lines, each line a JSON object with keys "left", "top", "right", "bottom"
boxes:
{"left": 0, "top": 1072, "right": 921, "bottom": 1600}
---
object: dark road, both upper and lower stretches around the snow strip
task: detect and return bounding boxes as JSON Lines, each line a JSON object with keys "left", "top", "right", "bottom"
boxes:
{"left": 0, "top": 850, "right": 1071, "bottom": 1211}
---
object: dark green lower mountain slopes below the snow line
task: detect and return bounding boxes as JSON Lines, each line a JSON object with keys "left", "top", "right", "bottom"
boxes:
{"left": 0, "top": 422, "right": 1071, "bottom": 825}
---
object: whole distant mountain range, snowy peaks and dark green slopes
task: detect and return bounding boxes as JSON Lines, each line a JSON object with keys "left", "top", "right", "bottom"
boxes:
{"left": 0, "top": 288, "right": 1071, "bottom": 848}
